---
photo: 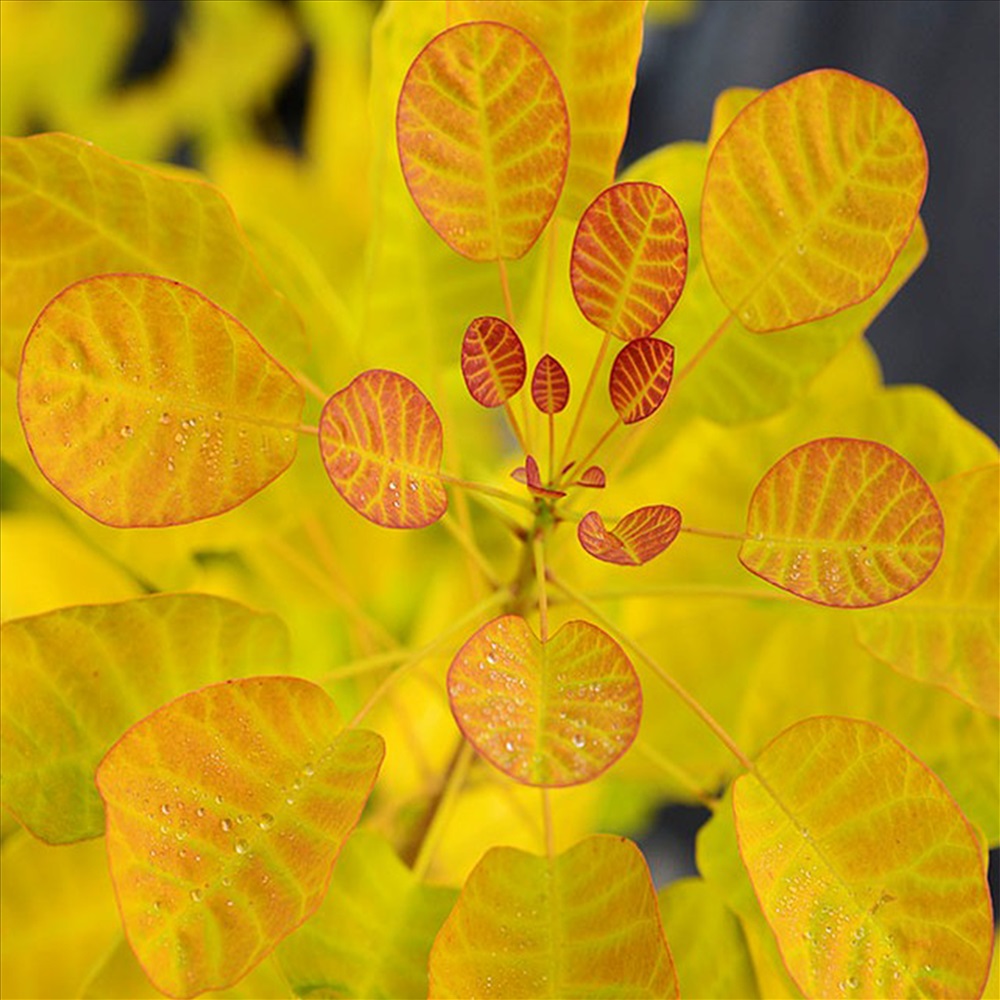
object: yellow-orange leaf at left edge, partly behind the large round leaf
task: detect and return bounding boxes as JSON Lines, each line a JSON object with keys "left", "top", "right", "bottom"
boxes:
{"left": 0, "top": 134, "right": 305, "bottom": 375}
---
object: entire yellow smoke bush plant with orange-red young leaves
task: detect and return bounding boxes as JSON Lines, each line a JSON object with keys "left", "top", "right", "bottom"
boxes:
{"left": 2, "top": 2, "right": 1000, "bottom": 997}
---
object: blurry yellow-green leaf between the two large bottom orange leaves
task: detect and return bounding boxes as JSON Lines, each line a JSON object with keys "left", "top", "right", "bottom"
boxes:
{"left": 277, "top": 829, "right": 458, "bottom": 1000}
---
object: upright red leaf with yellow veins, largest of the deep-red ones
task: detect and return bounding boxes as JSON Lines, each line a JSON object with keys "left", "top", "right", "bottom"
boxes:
{"left": 570, "top": 181, "right": 688, "bottom": 340}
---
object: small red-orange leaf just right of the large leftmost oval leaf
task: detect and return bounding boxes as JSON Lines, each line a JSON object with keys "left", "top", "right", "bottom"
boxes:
{"left": 319, "top": 369, "right": 448, "bottom": 528}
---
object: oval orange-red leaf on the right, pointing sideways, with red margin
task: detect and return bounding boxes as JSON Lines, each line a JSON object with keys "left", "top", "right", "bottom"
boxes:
{"left": 740, "top": 438, "right": 944, "bottom": 608}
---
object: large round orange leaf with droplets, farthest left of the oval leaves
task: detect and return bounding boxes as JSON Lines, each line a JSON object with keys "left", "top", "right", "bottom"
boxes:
{"left": 18, "top": 274, "right": 304, "bottom": 528}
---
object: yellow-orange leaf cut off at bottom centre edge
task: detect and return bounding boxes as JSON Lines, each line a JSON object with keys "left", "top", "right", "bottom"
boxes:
{"left": 429, "top": 836, "right": 678, "bottom": 998}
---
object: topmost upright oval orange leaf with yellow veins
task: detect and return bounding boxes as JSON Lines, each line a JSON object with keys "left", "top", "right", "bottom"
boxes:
{"left": 396, "top": 22, "right": 569, "bottom": 260}
